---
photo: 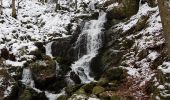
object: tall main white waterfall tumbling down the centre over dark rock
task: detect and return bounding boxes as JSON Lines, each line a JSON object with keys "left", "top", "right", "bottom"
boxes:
{"left": 71, "top": 12, "right": 106, "bottom": 83}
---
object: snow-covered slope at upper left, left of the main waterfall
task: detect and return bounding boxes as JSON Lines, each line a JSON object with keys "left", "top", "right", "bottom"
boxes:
{"left": 0, "top": 0, "right": 73, "bottom": 60}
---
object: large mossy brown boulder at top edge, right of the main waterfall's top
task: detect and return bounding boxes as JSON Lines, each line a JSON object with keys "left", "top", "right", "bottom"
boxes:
{"left": 107, "top": 0, "right": 139, "bottom": 20}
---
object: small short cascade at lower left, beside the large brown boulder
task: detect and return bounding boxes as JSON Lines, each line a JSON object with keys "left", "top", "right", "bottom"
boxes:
{"left": 21, "top": 68, "right": 34, "bottom": 88}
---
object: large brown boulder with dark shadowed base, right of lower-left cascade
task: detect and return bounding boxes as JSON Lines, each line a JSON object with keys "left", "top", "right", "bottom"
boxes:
{"left": 29, "top": 59, "right": 66, "bottom": 93}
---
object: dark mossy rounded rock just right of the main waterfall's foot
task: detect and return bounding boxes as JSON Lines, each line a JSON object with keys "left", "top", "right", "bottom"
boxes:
{"left": 102, "top": 67, "right": 124, "bottom": 80}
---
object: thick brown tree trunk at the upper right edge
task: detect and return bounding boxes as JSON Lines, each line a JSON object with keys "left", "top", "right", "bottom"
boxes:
{"left": 158, "top": 0, "right": 170, "bottom": 55}
